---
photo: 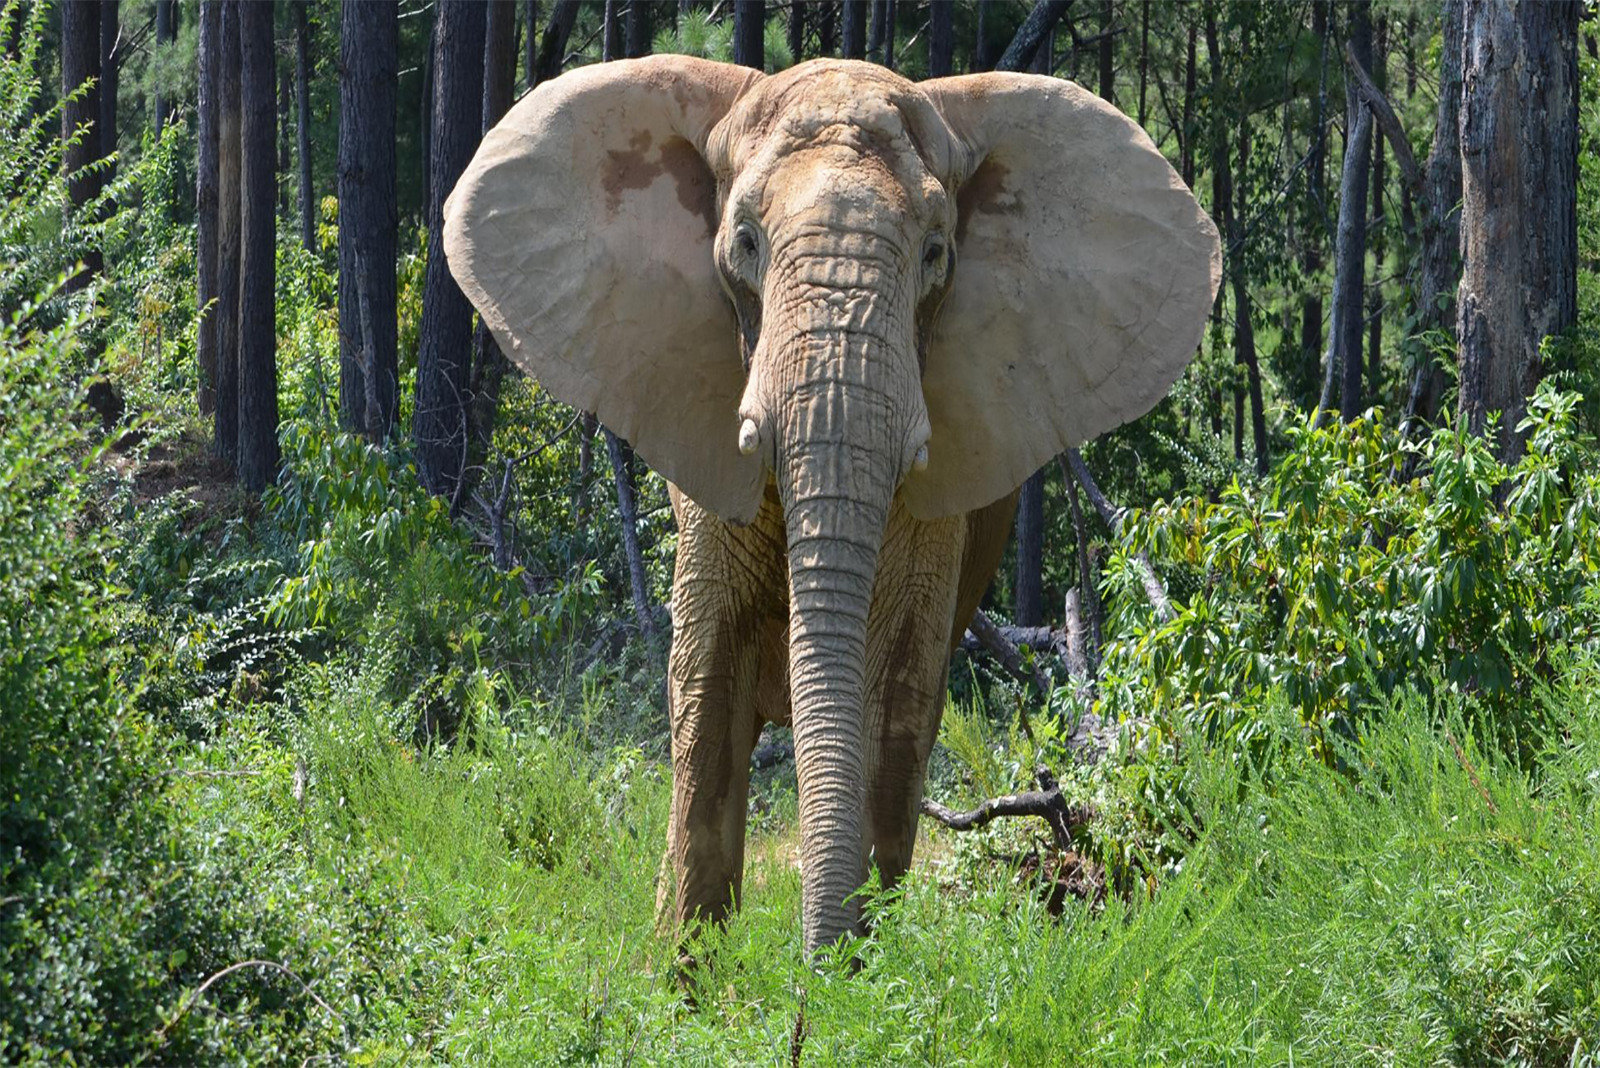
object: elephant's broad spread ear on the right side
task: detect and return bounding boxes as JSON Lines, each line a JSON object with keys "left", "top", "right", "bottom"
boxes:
{"left": 906, "top": 74, "right": 1221, "bottom": 518}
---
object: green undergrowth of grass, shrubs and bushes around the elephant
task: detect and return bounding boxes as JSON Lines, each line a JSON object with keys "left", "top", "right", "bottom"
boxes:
{"left": 9, "top": 4, "right": 1600, "bottom": 1066}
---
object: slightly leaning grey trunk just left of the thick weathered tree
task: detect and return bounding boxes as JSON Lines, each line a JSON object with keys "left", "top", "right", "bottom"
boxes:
{"left": 1406, "top": 0, "right": 1464, "bottom": 430}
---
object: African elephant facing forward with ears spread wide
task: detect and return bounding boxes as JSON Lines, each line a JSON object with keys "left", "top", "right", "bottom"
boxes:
{"left": 443, "top": 56, "right": 1221, "bottom": 953}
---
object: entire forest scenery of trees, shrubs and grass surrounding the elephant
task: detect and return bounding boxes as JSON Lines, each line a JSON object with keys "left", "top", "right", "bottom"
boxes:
{"left": 0, "top": 0, "right": 1600, "bottom": 1065}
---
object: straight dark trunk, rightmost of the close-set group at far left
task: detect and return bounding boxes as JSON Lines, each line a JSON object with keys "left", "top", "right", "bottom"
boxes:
{"left": 238, "top": 2, "right": 278, "bottom": 492}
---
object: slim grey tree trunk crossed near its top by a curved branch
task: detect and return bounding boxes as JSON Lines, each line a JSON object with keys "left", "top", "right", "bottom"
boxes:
{"left": 1334, "top": 0, "right": 1373, "bottom": 422}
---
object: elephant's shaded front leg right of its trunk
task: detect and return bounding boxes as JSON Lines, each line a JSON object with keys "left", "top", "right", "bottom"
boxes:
{"left": 862, "top": 500, "right": 966, "bottom": 889}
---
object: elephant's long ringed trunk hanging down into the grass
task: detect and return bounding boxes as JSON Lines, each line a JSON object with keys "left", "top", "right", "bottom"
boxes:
{"left": 774, "top": 281, "right": 926, "bottom": 951}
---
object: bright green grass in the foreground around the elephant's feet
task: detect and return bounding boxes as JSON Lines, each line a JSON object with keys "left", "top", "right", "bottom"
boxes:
{"left": 168, "top": 665, "right": 1600, "bottom": 1065}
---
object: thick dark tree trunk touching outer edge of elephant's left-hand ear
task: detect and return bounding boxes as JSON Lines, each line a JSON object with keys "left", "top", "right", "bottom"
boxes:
{"left": 413, "top": 0, "right": 485, "bottom": 510}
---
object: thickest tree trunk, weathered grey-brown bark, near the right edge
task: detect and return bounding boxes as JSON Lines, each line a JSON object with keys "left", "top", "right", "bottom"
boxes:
{"left": 1459, "top": 0, "right": 1578, "bottom": 462}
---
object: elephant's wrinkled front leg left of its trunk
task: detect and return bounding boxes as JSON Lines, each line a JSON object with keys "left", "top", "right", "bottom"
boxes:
{"left": 667, "top": 491, "right": 784, "bottom": 932}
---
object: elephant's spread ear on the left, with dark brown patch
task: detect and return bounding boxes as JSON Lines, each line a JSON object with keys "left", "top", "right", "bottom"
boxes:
{"left": 445, "top": 56, "right": 763, "bottom": 521}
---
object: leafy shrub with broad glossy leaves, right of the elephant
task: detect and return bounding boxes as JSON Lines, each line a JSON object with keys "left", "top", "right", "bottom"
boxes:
{"left": 1102, "top": 385, "right": 1600, "bottom": 743}
